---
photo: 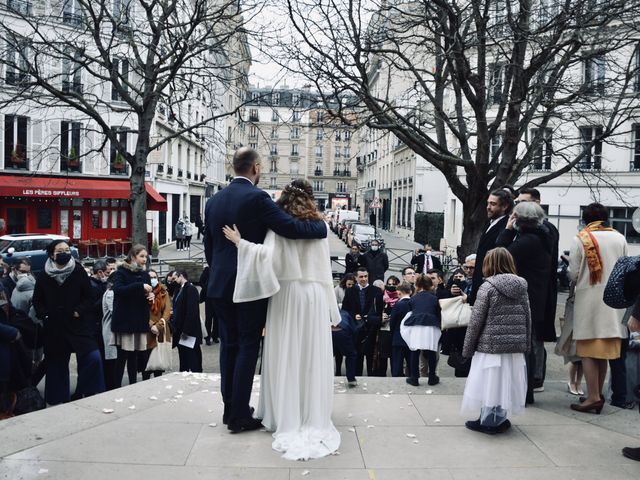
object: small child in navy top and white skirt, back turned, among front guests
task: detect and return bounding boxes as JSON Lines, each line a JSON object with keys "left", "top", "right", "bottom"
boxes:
{"left": 400, "top": 275, "right": 442, "bottom": 387}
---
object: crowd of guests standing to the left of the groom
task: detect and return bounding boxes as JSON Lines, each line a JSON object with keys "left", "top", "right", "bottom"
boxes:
{"left": 0, "top": 240, "right": 218, "bottom": 417}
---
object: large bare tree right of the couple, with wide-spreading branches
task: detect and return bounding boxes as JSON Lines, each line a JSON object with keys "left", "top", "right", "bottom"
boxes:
{"left": 274, "top": 0, "right": 640, "bottom": 252}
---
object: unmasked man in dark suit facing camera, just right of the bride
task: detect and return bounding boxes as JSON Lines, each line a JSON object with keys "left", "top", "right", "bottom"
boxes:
{"left": 342, "top": 267, "right": 384, "bottom": 376}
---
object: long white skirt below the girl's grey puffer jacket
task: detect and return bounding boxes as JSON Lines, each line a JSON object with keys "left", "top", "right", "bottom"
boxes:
{"left": 461, "top": 352, "right": 527, "bottom": 414}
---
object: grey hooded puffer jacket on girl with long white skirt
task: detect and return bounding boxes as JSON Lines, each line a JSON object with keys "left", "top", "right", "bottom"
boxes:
{"left": 462, "top": 273, "right": 531, "bottom": 358}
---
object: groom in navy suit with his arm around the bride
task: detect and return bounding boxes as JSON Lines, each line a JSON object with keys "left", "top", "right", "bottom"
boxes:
{"left": 204, "top": 147, "right": 327, "bottom": 433}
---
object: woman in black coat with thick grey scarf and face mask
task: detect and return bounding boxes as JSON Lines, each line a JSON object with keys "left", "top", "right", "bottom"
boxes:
{"left": 33, "top": 240, "right": 104, "bottom": 405}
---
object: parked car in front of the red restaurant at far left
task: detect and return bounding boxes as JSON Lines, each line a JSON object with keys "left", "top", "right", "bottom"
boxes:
{"left": 0, "top": 233, "right": 78, "bottom": 273}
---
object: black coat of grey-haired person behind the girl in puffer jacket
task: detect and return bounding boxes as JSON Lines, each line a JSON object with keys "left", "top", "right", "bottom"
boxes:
{"left": 496, "top": 226, "right": 556, "bottom": 342}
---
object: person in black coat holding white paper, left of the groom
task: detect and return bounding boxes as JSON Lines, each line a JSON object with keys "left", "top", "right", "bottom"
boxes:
{"left": 173, "top": 270, "right": 202, "bottom": 372}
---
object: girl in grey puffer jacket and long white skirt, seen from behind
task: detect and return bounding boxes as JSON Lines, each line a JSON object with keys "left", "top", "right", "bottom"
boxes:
{"left": 462, "top": 247, "right": 531, "bottom": 434}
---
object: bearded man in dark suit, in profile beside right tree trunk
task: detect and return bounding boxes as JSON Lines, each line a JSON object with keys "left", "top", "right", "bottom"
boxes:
{"left": 468, "top": 189, "right": 513, "bottom": 305}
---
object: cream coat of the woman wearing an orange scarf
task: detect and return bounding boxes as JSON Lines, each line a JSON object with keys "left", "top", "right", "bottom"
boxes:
{"left": 569, "top": 231, "right": 627, "bottom": 340}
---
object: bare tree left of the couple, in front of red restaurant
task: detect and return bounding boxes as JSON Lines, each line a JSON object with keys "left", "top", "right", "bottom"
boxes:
{"left": 0, "top": 0, "right": 254, "bottom": 244}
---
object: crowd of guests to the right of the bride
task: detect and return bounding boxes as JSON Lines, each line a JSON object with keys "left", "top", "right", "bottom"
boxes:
{"left": 333, "top": 187, "right": 640, "bottom": 450}
